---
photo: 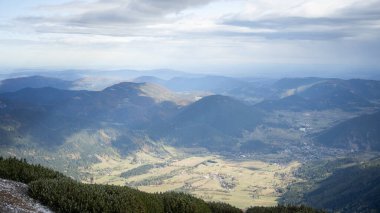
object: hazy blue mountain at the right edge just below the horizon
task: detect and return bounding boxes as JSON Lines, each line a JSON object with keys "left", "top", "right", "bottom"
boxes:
{"left": 257, "top": 78, "right": 380, "bottom": 111}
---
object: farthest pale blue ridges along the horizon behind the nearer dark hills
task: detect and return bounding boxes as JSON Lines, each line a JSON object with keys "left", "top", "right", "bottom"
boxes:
{"left": 0, "top": 75, "right": 380, "bottom": 111}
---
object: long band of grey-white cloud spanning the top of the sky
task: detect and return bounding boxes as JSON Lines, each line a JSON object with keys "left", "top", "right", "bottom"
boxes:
{"left": 17, "top": 0, "right": 380, "bottom": 40}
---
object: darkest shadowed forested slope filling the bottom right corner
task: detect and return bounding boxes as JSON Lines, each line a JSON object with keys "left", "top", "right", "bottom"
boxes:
{"left": 305, "top": 164, "right": 380, "bottom": 212}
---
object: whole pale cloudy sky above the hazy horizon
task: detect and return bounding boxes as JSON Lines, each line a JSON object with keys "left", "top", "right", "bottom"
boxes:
{"left": 0, "top": 0, "right": 380, "bottom": 73}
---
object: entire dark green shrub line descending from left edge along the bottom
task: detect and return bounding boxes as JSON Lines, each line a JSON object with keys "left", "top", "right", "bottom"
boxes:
{"left": 0, "top": 157, "right": 318, "bottom": 213}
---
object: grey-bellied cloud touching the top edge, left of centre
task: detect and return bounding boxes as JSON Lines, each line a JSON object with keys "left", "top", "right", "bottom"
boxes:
{"left": 35, "top": 0, "right": 217, "bottom": 26}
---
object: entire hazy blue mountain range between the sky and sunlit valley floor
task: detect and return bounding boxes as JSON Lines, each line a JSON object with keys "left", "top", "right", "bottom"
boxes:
{"left": 0, "top": 75, "right": 380, "bottom": 212}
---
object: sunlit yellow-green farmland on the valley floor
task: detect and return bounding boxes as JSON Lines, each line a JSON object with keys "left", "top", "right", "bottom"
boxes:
{"left": 83, "top": 146, "right": 300, "bottom": 208}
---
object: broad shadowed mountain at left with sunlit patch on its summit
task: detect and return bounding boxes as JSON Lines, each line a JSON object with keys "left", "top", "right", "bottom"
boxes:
{"left": 0, "top": 83, "right": 177, "bottom": 146}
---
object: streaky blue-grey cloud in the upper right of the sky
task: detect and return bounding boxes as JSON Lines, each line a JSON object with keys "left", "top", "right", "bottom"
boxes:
{"left": 221, "top": 1, "right": 380, "bottom": 40}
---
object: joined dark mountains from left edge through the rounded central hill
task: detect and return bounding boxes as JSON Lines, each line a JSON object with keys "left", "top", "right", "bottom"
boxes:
{"left": 0, "top": 82, "right": 262, "bottom": 152}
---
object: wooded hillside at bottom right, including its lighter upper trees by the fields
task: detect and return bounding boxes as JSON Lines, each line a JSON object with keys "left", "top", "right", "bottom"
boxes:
{"left": 280, "top": 158, "right": 380, "bottom": 212}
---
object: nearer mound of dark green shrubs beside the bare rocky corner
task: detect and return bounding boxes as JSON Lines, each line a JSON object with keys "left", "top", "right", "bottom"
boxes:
{"left": 29, "top": 179, "right": 218, "bottom": 213}
